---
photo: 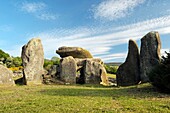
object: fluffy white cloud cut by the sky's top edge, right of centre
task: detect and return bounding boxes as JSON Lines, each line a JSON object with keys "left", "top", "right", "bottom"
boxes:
{"left": 93, "top": 0, "right": 145, "bottom": 21}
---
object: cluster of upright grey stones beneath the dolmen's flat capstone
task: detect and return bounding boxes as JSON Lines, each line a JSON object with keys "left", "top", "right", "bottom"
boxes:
{"left": 59, "top": 56, "right": 108, "bottom": 85}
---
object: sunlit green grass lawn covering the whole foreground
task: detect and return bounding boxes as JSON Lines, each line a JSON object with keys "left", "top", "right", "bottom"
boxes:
{"left": 0, "top": 84, "right": 170, "bottom": 113}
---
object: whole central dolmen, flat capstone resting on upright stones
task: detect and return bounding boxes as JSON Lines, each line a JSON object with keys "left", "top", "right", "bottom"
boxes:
{"left": 56, "top": 47, "right": 108, "bottom": 85}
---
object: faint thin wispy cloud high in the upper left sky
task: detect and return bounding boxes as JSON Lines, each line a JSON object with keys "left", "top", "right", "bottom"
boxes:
{"left": 21, "top": 2, "right": 57, "bottom": 20}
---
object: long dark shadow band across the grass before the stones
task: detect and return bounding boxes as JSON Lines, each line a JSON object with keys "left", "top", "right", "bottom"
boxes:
{"left": 40, "top": 85, "right": 168, "bottom": 99}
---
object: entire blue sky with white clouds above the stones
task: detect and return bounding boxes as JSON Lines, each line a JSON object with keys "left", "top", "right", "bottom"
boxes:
{"left": 0, "top": 0, "right": 170, "bottom": 62}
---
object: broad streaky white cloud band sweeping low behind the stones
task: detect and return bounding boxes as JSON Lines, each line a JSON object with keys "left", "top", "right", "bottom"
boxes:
{"left": 10, "top": 16, "right": 170, "bottom": 62}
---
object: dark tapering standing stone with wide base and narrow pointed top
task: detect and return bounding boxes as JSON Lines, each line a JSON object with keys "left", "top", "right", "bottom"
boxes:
{"left": 116, "top": 40, "right": 140, "bottom": 86}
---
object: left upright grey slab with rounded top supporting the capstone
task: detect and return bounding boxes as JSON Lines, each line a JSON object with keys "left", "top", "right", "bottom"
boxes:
{"left": 60, "top": 56, "right": 77, "bottom": 84}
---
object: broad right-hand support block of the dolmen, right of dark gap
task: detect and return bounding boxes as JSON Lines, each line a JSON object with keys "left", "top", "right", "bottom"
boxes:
{"left": 84, "top": 59, "right": 108, "bottom": 85}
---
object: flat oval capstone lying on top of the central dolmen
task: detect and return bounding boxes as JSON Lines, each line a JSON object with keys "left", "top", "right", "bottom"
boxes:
{"left": 56, "top": 47, "right": 93, "bottom": 58}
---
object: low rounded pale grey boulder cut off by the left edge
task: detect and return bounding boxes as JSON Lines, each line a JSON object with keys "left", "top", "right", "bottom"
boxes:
{"left": 0, "top": 65, "right": 15, "bottom": 85}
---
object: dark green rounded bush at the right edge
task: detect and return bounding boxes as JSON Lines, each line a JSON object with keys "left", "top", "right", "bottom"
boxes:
{"left": 149, "top": 52, "right": 170, "bottom": 93}
